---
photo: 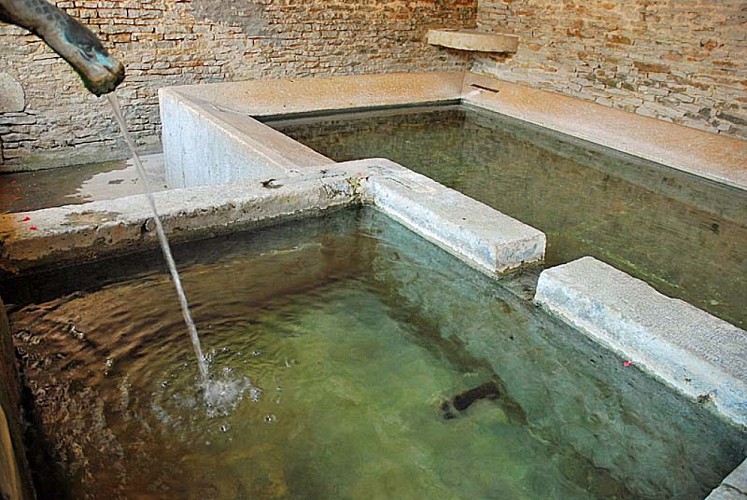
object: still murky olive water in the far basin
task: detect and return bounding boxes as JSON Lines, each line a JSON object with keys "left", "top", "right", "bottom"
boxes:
{"left": 267, "top": 106, "right": 747, "bottom": 328}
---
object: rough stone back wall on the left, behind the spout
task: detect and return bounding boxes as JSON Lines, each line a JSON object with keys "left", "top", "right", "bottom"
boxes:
{"left": 0, "top": 0, "right": 476, "bottom": 170}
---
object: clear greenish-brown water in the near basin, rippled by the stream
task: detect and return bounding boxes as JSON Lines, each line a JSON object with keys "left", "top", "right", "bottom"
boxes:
{"left": 5, "top": 210, "right": 747, "bottom": 499}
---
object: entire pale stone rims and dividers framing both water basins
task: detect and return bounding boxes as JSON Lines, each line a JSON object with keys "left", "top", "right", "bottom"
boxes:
{"left": 0, "top": 73, "right": 747, "bottom": 498}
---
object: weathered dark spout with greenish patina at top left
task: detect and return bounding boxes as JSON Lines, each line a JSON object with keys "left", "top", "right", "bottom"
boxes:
{"left": 0, "top": 0, "right": 125, "bottom": 95}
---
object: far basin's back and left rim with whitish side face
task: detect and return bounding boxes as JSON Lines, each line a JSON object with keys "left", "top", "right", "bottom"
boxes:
{"left": 159, "top": 73, "right": 464, "bottom": 188}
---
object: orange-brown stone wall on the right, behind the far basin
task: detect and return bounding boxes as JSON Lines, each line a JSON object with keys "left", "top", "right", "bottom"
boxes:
{"left": 473, "top": 0, "right": 747, "bottom": 139}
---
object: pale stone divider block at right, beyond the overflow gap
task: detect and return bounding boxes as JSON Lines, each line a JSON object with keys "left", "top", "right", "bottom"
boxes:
{"left": 535, "top": 257, "right": 747, "bottom": 427}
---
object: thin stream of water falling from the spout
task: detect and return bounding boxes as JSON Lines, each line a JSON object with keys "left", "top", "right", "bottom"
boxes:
{"left": 107, "top": 93, "right": 210, "bottom": 386}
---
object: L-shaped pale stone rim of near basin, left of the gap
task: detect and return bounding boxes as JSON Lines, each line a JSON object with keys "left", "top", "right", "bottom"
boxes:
{"left": 0, "top": 159, "right": 545, "bottom": 275}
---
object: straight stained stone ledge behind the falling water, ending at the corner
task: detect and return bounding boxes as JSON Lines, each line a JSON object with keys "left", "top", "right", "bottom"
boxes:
{"left": 0, "top": 168, "right": 357, "bottom": 273}
